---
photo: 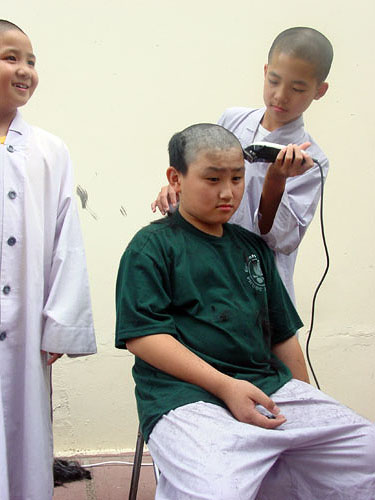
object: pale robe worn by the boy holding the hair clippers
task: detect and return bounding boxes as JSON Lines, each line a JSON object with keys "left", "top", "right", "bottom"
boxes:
{"left": 218, "top": 108, "right": 328, "bottom": 302}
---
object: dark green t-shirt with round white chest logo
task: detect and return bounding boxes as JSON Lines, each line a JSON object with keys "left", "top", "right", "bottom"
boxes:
{"left": 116, "top": 212, "right": 302, "bottom": 441}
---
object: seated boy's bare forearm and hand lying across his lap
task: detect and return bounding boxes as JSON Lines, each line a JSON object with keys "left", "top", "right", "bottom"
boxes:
{"left": 126, "top": 334, "right": 286, "bottom": 429}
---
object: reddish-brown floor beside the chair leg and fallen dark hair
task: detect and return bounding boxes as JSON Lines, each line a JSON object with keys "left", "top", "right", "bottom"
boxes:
{"left": 53, "top": 453, "right": 156, "bottom": 500}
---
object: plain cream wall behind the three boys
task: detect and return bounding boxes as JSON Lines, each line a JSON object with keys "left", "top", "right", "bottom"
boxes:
{"left": 1, "top": 0, "right": 375, "bottom": 454}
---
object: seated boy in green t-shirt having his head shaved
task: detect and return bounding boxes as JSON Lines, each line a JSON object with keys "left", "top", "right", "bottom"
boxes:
{"left": 116, "top": 124, "right": 375, "bottom": 500}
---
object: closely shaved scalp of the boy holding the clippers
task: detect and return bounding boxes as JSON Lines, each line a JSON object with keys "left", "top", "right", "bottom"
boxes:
{"left": 268, "top": 27, "right": 333, "bottom": 83}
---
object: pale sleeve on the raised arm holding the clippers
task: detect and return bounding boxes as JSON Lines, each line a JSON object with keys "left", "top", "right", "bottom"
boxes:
{"left": 255, "top": 158, "right": 328, "bottom": 255}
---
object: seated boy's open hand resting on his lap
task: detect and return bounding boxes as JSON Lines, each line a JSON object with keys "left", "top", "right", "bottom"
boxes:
{"left": 221, "top": 379, "right": 286, "bottom": 429}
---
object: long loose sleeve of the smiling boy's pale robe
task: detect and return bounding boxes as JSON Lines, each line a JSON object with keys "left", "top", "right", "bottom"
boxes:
{"left": 41, "top": 145, "right": 96, "bottom": 355}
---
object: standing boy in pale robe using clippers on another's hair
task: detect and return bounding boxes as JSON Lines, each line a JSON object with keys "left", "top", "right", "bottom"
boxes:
{"left": 152, "top": 27, "right": 333, "bottom": 301}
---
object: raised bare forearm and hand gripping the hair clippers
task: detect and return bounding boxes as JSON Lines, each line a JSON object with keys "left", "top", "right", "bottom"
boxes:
{"left": 258, "top": 142, "right": 314, "bottom": 235}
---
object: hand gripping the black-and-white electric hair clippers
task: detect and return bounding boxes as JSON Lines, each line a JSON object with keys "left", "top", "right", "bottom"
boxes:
{"left": 267, "top": 142, "right": 314, "bottom": 179}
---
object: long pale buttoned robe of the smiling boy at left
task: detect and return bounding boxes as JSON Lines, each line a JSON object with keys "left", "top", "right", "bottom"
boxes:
{"left": 0, "top": 113, "right": 96, "bottom": 500}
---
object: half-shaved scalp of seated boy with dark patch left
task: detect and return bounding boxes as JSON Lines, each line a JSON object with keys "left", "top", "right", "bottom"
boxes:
{"left": 168, "top": 123, "right": 242, "bottom": 175}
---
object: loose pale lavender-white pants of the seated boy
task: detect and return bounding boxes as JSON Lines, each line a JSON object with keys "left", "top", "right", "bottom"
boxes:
{"left": 148, "top": 380, "right": 375, "bottom": 500}
